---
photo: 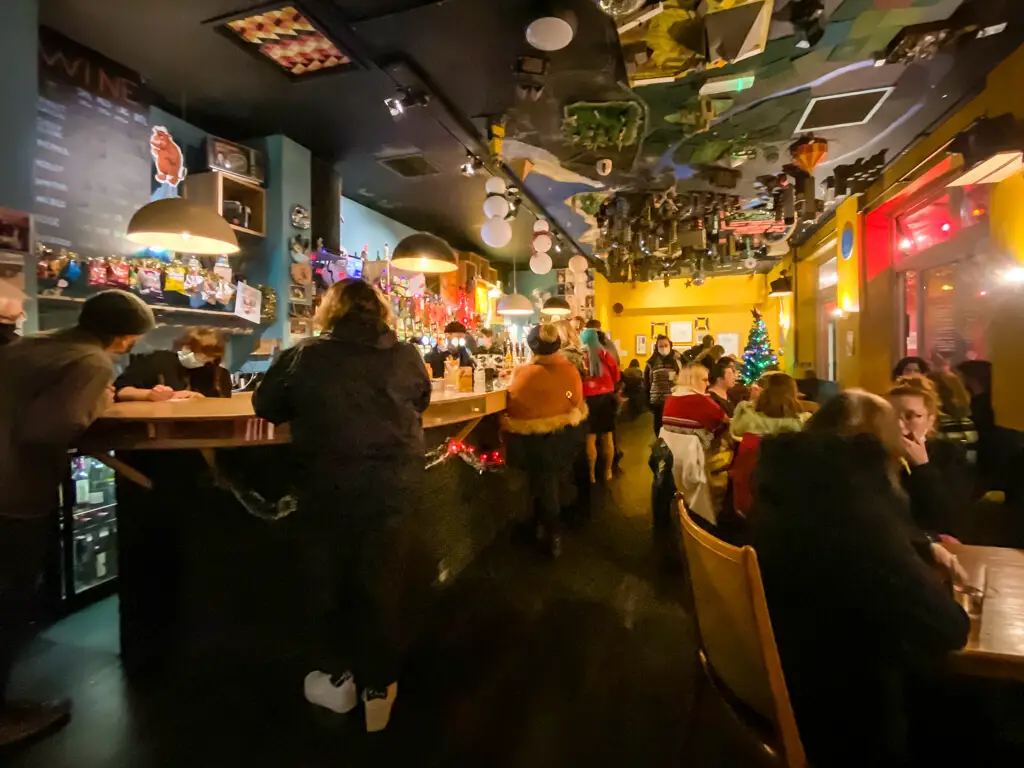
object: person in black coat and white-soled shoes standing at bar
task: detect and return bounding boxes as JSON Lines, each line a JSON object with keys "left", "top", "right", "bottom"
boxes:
{"left": 253, "top": 279, "right": 430, "bottom": 731}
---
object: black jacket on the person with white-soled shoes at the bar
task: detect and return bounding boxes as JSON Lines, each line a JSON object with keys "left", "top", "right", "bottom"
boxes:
{"left": 253, "top": 315, "right": 430, "bottom": 501}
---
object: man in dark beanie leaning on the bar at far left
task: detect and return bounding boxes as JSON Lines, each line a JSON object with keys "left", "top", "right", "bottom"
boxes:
{"left": 0, "top": 291, "right": 156, "bottom": 748}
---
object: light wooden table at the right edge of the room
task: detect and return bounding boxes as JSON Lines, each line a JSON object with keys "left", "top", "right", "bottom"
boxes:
{"left": 945, "top": 544, "right": 1024, "bottom": 682}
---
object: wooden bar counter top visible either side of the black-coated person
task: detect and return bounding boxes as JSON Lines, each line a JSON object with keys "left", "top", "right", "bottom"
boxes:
{"left": 76, "top": 389, "right": 508, "bottom": 453}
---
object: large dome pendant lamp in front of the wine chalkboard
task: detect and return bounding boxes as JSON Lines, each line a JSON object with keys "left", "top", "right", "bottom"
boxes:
{"left": 126, "top": 198, "right": 242, "bottom": 256}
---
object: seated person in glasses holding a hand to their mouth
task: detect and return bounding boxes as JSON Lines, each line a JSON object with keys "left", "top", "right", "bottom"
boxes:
{"left": 889, "top": 377, "right": 971, "bottom": 536}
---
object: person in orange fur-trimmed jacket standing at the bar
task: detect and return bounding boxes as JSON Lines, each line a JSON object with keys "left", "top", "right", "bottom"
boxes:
{"left": 505, "top": 324, "right": 587, "bottom": 557}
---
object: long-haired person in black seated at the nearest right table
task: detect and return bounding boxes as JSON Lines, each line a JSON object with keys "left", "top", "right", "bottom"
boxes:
{"left": 751, "top": 392, "right": 970, "bottom": 768}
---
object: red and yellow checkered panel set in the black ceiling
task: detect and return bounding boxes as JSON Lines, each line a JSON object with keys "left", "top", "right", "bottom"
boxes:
{"left": 212, "top": 2, "right": 354, "bottom": 80}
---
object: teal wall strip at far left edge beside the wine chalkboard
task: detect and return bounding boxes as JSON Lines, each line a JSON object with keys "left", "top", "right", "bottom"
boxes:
{"left": 0, "top": 0, "right": 39, "bottom": 333}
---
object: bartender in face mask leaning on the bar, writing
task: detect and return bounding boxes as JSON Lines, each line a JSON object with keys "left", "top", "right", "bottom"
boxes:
{"left": 114, "top": 328, "right": 231, "bottom": 402}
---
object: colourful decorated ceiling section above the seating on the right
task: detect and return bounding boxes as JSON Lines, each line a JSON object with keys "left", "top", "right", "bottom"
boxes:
{"left": 504, "top": 0, "right": 1006, "bottom": 282}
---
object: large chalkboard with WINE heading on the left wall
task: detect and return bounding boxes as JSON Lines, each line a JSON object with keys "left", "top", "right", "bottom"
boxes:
{"left": 34, "top": 29, "right": 153, "bottom": 257}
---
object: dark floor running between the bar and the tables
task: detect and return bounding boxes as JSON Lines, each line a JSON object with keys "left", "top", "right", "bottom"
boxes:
{"left": 0, "top": 417, "right": 770, "bottom": 768}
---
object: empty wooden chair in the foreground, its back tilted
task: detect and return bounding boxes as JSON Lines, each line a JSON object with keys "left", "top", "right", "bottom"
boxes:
{"left": 678, "top": 500, "right": 807, "bottom": 768}
